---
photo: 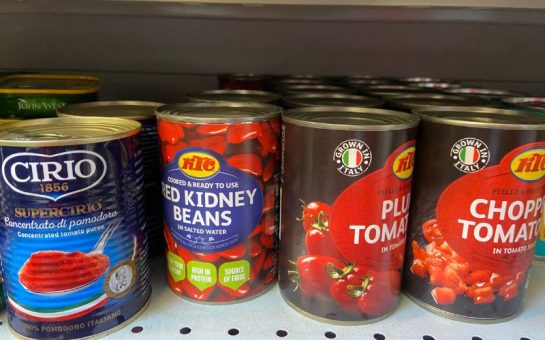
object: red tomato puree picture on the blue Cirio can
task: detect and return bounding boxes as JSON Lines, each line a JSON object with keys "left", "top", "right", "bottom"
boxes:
{"left": 19, "top": 250, "right": 110, "bottom": 294}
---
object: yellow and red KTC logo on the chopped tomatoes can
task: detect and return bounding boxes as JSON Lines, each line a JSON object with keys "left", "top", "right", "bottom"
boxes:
{"left": 511, "top": 148, "right": 545, "bottom": 182}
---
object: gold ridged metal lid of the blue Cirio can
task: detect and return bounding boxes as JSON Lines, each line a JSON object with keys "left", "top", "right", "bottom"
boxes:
{"left": 0, "top": 117, "right": 141, "bottom": 147}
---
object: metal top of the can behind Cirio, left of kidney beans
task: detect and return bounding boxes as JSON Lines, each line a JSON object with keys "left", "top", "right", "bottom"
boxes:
{"left": 57, "top": 100, "right": 164, "bottom": 120}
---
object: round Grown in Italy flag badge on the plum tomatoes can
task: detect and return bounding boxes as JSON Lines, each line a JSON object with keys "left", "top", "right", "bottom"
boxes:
{"left": 333, "top": 139, "right": 372, "bottom": 177}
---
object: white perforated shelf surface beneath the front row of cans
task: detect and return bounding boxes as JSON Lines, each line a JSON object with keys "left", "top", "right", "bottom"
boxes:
{"left": 0, "top": 260, "right": 545, "bottom": 340}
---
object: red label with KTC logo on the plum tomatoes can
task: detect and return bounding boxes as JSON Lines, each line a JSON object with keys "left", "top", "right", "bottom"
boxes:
{"left": 329, "top": 141, "right": 415, "bottom": 270}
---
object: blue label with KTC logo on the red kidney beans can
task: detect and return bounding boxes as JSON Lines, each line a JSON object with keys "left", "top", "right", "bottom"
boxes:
{"left": 162, "top": 148, "right": 263, "bottom": 253}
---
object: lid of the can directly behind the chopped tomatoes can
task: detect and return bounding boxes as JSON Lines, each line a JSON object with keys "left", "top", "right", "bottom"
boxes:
{"left": 387, "top": 94, "right": 488, "bottom": 109}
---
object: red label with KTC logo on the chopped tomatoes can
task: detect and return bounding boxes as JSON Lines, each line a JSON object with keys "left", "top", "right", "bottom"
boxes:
{"left": 437, "top": 143, "right": 545, "bottom": 274}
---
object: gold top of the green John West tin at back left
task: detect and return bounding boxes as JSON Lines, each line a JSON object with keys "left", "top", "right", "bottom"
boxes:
{"left": 0, "top": 73, "right": 99, "bottom": 94}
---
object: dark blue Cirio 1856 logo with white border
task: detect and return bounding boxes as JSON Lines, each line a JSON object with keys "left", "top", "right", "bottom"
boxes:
{"left": 2, "top": 150, "right": 107, "bottom": 201}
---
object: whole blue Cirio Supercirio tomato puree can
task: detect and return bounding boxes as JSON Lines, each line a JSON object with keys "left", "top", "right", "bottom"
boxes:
{"left": 0, "top": 118, "right": 151, "bottom": 339}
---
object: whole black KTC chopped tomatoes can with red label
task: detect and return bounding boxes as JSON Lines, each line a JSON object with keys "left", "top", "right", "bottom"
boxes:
{"left": 403, "top": 107, "right": 545, "bottom": 322}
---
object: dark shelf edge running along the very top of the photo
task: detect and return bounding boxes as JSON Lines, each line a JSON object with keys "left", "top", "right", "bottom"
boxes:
{"left": 0, "top": 0, "right": 545, "bottom": 26}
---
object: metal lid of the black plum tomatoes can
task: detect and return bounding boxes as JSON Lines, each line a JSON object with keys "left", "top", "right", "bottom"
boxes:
{"left": 282, "top": 106, "right": 419, "bottom": 131}
